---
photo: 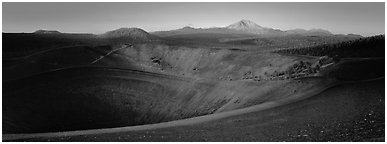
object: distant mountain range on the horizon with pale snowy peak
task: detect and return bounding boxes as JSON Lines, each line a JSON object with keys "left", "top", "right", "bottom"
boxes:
{"left": 29, "top": 20, "right": 362, "bottom": 43}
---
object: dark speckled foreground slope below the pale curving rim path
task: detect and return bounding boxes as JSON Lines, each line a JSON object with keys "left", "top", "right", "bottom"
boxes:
{"left": 8, "top": 79, "right": 385, "bottom": 141}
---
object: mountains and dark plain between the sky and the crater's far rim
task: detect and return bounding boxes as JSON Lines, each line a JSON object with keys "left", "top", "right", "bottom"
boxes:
{"left": 3, "top": 20, "right": 370, "bottom": 56}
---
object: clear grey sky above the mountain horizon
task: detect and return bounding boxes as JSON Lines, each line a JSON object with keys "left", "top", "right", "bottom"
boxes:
{"left": 2, "top": 2, "right": 385, "bottom": 36}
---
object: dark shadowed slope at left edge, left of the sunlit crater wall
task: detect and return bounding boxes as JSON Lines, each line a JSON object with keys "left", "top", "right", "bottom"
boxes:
{"left": 3, "top": 46, "right": 126, "bottom": 81}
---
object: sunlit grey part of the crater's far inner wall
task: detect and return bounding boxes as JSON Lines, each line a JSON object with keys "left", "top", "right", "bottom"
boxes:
{"left": 99, "top": 44, "right": 317, "bottom": 80}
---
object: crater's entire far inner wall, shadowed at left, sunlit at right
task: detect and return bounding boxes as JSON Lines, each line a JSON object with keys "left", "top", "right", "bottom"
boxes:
{"left": 4, "top": 44, "right": 317, "bottom": 80}
